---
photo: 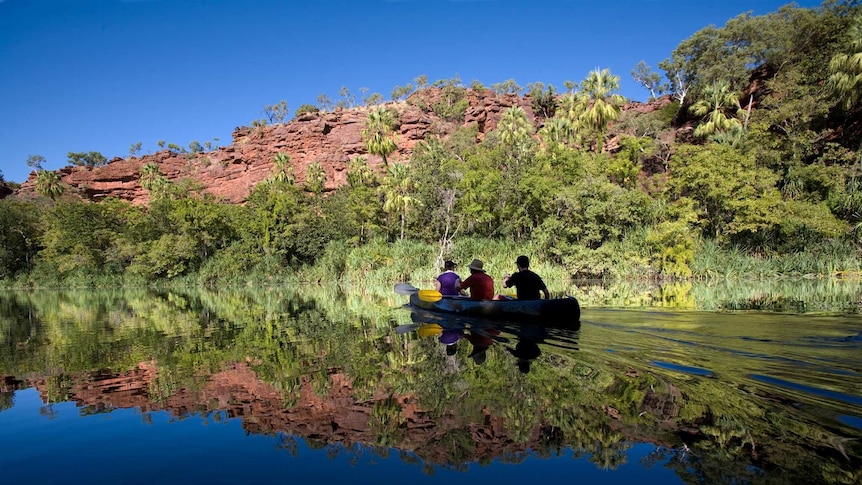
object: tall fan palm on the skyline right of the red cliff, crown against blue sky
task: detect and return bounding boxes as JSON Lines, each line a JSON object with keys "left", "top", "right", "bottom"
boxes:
{"left": 580, "top": 69, "right": 625, "bottom": 153}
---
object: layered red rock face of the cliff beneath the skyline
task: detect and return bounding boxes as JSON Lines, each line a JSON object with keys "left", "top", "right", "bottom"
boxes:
{"left": 16, "top": 88, "right": 676, "bottom": 204}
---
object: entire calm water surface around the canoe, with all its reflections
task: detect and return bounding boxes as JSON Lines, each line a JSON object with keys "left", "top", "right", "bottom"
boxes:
{"left": 0, "top": 283, "right": 862, "bottom": 484}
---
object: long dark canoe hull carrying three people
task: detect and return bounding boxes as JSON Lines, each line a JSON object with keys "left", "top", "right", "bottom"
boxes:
{"left": 410, "top": 293, "right": 581, "bottom": 326}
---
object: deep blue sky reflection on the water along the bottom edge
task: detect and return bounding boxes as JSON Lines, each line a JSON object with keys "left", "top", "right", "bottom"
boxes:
{"left": 0, "top": 388, "right": 682, "bottom": 485}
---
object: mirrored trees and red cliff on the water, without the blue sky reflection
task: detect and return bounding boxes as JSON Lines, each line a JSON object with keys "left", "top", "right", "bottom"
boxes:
{"left": 0, "top": 288, "right": 862, "bottom": 483}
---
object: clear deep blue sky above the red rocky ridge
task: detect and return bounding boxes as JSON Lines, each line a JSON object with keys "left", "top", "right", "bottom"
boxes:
{"left": 0, "top": 0, "right": 821, "bottom": 182}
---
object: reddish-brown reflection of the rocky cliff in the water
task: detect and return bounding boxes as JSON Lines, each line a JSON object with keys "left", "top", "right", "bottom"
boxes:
{"left": 0, "top": 362, "right": 572, "bottom": 467}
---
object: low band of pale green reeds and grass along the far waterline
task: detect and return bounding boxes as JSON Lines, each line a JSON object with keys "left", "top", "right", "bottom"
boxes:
{"left": 5, "top": 236, "right": 862, "bottom": 314}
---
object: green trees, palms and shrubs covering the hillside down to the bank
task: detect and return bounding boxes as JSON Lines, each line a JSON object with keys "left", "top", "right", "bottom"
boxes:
{"left": 0, "top": 1, "right": 862, "bottom": 306}
